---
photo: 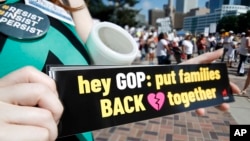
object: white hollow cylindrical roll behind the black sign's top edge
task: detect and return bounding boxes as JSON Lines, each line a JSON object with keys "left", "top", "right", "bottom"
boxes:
{"left": 86, "top": 22, "right": 138, "bottom": 65}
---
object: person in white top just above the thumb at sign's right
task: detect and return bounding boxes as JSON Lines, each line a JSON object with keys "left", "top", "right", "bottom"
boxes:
{"left": 182, "top": 35, "right": 194, "bottom": 59}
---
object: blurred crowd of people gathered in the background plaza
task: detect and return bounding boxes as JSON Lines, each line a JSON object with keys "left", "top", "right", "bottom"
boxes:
{"left": 130, "top": 27, "right": 250, "bottom": 98}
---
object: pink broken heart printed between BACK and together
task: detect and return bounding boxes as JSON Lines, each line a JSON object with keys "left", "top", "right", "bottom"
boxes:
{"left": 147, "top": 92, "right": 165, "bottom": 111}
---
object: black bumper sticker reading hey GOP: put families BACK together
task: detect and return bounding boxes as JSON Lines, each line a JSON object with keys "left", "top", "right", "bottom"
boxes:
{"left": 49, "top": 63, "right": 234, "bottom": 137}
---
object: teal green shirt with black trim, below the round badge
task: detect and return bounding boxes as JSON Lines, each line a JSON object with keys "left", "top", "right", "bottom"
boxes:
{"left": 0, "top": 0, "right": 92, "bottom": 140}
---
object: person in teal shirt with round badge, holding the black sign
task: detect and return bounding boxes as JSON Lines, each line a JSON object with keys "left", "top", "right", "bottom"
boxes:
{"left": 0, "top": 0, "right": 241, "bottom": 141}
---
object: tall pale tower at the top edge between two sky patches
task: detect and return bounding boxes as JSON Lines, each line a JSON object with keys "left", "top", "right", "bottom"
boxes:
{"left": 175, "top": 0, "right": 198, "bottom": 13}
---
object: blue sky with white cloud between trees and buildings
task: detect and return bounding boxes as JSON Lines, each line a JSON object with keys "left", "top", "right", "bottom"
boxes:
{"left": 104, "top": 0, "right": 207, "bottom": 19}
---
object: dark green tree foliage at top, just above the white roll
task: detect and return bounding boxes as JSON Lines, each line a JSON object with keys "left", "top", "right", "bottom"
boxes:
{"left": 87, "top": 0, "right": 139, "bottom": 26}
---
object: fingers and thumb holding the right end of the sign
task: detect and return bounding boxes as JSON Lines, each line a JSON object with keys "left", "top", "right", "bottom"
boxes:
{"left": 182, "top": 49, "right": 240, "bottom": 116}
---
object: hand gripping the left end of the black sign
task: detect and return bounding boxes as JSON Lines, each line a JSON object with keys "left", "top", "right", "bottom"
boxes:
{"left": 0, "top": 67, "right": 63, "bottom": 141}
